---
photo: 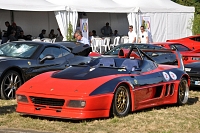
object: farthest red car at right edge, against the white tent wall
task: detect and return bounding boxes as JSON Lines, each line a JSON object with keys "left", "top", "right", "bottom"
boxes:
{"left": 167, "top": 35, "right": 200, "bottom": 49}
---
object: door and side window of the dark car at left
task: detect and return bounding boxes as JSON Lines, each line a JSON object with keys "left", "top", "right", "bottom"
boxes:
{"left": 28, "top": 46, "right": 73, "bottom": 77}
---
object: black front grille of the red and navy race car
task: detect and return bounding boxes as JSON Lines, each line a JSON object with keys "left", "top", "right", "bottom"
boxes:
{"left": 30, "top": 96, "right": 65, "bottom": 106}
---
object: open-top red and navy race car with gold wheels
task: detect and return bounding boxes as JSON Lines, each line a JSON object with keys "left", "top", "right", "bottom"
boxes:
{"left": 16, "top": 46, "right": 190, "bottom": 119}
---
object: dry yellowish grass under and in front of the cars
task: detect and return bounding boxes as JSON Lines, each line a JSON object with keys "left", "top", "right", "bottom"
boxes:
{"left": 0, "top": 90, "right": 200, "bottom": 133}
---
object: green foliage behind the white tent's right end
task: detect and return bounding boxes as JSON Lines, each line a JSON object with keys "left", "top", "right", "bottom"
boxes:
{"left": 172, "top": 0, "right": 200, "bottom": 35}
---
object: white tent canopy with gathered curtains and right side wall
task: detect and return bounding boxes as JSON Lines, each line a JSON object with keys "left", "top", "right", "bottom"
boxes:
{"left": 0, "top": 0, "right": 194, "bottom": 41}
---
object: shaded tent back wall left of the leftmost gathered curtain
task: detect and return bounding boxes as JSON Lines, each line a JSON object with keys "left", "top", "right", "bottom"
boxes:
{"left": 14, "top": 11, "right": 58, "bottom": 37}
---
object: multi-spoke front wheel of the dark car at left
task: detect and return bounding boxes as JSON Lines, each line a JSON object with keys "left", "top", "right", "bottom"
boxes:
{"left": 1, "top": 70, "right": 22, "bottom": 100}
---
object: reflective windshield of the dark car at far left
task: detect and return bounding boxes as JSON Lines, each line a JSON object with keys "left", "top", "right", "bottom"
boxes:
{"left": 0, "top": 42, "right": 39, "bottom": 58}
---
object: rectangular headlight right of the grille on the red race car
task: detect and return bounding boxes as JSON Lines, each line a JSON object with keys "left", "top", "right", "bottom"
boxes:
{"left": 67, "top": 100, "right": 86, "bottom": 108}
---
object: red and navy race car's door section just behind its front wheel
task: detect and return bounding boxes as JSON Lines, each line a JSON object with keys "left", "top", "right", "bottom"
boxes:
{"left": 130, "top": 60, "right": 164, "bottom": 109}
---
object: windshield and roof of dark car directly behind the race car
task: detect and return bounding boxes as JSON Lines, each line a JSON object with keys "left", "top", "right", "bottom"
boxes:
{"left": 103, "top": 44, "right": 165, "bottom": 55}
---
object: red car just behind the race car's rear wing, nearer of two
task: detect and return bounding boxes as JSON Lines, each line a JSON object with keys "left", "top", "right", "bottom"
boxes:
{"left": 153, "top": 42, "right": 200, "bottom": 64}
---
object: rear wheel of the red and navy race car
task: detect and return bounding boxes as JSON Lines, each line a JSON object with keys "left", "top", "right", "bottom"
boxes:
{"left": 177, "top": 78, "right": 189, "bottom": 106}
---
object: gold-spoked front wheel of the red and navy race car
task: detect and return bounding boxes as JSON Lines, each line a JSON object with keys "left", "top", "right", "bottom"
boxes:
{"left": 112, "top": 85, "right": 131, "bottom": 117}
